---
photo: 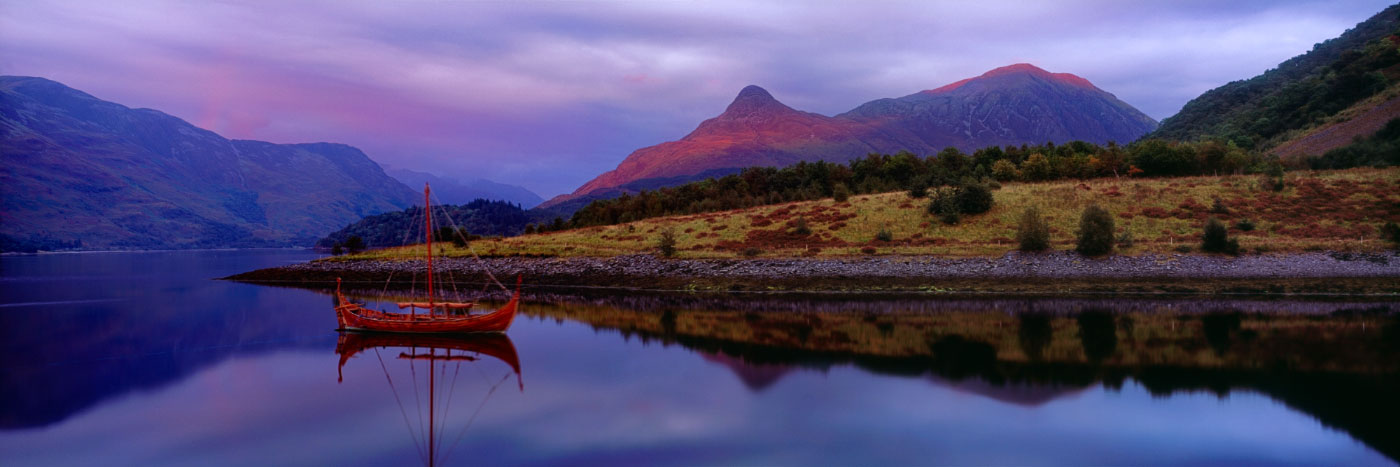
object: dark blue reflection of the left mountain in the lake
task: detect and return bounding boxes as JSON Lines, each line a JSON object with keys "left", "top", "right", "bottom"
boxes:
{"left": 0, "top": 292, "right": 335, "bottom": 429}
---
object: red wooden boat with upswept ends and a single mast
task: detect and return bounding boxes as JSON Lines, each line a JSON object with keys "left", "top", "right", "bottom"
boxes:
{"left": 336, "top": 185, "right": 521, "bottom": 334}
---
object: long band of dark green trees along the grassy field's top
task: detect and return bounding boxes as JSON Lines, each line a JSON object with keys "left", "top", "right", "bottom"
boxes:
{"left": 551, "top": 140, "right": 1281, "bottom": 234}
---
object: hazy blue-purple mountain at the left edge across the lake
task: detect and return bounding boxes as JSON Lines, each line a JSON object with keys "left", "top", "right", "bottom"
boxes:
{"left": 0, "top": 77, "right": 417, "bottom": 250}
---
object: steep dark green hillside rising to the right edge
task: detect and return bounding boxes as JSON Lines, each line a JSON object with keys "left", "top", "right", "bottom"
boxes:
{"left": 1149, "top": 4, "right": 1400, "bottom": 157}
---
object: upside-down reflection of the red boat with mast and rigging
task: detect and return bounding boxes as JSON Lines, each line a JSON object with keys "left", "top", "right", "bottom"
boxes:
{"left": 336, "top": 333, "right": 525, "bottom": 466}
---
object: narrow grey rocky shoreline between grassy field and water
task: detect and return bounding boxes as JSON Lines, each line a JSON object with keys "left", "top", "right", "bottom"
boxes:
{"left": 227, "top": 252, "right": 1400, "bottom": 295}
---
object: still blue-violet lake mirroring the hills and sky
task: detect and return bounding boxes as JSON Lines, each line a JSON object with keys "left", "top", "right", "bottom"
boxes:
{"left": 0, "top": 250, "right": 1400, "bottom": 466}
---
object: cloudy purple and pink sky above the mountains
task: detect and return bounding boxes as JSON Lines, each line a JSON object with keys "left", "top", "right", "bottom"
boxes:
{"left": 0, "top": 0, "right": 1389, "bottom": 197}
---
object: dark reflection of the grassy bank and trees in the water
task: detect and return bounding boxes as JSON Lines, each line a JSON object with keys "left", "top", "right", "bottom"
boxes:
{"left": 529, "top": 296, "right": 1400, "bottom": 460}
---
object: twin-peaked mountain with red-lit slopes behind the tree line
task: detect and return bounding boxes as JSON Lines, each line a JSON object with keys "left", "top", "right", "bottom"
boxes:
{"left": 542, "top": 64, "right": 1156, "bottom": 208}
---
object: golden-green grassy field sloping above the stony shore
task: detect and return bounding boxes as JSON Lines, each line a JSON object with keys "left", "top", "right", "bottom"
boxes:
{"left": 340, "top": 168, "right": 1400, "bottom": 259}
